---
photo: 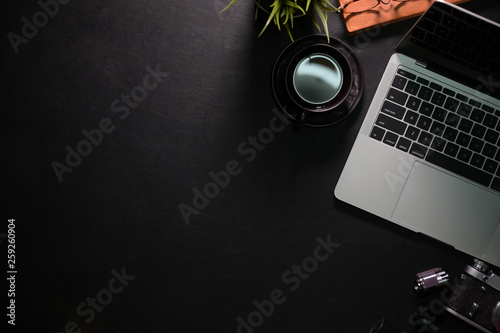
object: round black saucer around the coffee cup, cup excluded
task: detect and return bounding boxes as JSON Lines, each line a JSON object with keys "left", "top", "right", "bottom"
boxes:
{"left": 272, "top": 35, "right": 364, "bottom": 127}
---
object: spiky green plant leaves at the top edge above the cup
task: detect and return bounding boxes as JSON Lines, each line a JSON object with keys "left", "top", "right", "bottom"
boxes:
{"left": 222, "top": 0, "right": 339, "bottom": 41}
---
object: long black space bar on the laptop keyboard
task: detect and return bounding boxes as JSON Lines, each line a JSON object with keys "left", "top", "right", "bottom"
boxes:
{"left": 425, "top": 151, "right": 493, "bottom": 186}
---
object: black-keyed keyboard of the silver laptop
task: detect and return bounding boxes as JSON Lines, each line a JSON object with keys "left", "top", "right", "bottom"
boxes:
{"left": 370, "top": 68, "right": 500, "bottom": 192}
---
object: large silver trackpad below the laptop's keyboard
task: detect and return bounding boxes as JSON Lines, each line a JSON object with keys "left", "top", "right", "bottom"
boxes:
{"left": 393, "top": 162, "right": 500, "bottom": 257}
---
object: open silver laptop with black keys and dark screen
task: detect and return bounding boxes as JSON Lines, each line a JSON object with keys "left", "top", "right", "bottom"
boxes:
{"left": 335, "top": 0, "right": 500, "bottom": 266}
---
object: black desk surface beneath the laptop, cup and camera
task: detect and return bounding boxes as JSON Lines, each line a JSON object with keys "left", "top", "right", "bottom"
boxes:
{"left": 0, "top": 0, "right": 500, "bottom": 333}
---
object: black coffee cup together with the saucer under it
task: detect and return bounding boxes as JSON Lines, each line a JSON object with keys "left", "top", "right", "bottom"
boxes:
{"left": 273, "top": 35, "right": 364, "bottom": 127}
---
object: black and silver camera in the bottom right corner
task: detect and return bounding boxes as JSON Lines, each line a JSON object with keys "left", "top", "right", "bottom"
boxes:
{"left": 445, "top": 259, "right": 500, "bottom": 333}
